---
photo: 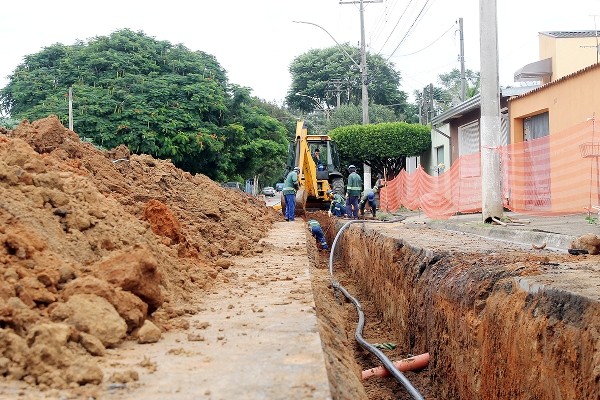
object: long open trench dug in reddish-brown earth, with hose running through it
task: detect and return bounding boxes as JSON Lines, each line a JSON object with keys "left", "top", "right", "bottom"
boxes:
{"left": 307, "top": 212, "right": 600, "bottom": 399}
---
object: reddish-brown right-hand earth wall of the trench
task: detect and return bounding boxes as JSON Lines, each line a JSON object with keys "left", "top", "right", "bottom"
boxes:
{"left": 329, "top": 221, "right": 600, "bottom": 400}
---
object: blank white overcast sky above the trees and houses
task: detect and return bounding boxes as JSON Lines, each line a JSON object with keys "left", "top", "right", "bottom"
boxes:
{"left": 0, "top": 0, "right": 600, "bottom": 108}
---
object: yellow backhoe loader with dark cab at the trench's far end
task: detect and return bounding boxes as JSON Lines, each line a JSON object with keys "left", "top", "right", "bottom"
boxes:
{"left": 281, "top": 120, "right": 345, "bottom": 216}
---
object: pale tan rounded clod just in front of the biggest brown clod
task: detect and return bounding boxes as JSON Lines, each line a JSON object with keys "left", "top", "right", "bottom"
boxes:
{"left": 50, "top": 294, "right": 127, "bottom": 347}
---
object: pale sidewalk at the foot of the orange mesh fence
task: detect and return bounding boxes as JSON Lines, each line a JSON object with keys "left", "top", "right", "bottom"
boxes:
{"left": 401, "top": 211, "right": 600, "bottom": 251}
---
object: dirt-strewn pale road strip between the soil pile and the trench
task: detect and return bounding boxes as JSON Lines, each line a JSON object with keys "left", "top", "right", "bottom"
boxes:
{"left": 0, "top": 220, "right": 331, "bottom": 400}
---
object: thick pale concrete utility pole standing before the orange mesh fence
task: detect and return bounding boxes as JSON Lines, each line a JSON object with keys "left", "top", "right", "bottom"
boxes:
{"left": 479, "top": 0, "right": 504, "bottom": 223}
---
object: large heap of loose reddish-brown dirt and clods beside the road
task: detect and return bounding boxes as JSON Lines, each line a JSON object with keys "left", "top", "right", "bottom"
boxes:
{"left": 0, "top": 116, "right": 280, "bottom": 389}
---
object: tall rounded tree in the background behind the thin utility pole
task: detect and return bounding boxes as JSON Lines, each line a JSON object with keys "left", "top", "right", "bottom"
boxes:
{"left": 286, "top": 44, "right": 408, "bottom": 116}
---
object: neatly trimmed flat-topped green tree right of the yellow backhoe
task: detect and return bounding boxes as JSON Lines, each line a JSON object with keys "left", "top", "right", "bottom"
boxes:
{"left": 329, "top": 122, "right": 431, "bottom": 179}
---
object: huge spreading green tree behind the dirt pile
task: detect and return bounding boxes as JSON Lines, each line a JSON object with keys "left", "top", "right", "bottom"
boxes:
{"left": 0, "top": 29, "right": 287, "bottom": 184}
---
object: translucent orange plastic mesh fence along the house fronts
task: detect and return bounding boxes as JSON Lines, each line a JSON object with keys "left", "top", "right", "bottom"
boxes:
{"left": 380, "top": 120, "right": 600, "bottom": 219}
